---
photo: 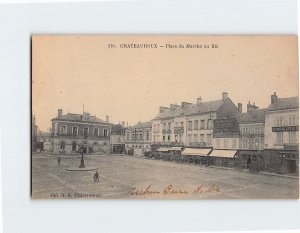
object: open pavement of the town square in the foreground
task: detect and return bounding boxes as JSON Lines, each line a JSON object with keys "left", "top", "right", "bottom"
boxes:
{"left": 32, "top": 154, "right": 299, "bottom": 199}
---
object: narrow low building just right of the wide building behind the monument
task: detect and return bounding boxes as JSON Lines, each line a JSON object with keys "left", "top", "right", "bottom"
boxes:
{"left": 110, "top": 123, "right": 125, "bottom": 154}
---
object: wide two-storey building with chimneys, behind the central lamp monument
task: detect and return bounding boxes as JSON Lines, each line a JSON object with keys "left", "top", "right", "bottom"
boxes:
{"left": 51, "top": 109, "right": 111, "bottom": 154}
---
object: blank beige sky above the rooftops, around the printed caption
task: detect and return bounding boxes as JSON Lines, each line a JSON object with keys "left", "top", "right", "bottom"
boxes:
{"left": 32, "top": 35, "right": 299, "bottom": 131}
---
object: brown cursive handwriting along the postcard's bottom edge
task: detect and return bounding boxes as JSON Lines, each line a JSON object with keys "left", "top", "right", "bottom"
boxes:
{"left": 128, "top": 184, "right": 221, "bottom": 196}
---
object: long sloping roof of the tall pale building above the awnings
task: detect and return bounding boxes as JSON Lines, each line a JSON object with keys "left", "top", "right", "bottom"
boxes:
{"left": 153, "top": 100, "right": 224, "bottom": 120}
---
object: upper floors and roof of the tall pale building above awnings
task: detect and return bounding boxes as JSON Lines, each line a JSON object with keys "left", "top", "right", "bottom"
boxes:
{"left": 152, "top": 92, "right": 239, "bottom": 147}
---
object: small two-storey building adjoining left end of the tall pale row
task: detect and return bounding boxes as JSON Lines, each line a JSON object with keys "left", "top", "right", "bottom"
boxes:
{"left": 124, "top": 121, "right": 152, "bottom": 155}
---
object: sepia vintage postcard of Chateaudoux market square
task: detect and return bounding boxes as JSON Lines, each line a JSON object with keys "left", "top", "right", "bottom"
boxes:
{"left": 31, "top": 35, "right": 299, "bottom": 199}
